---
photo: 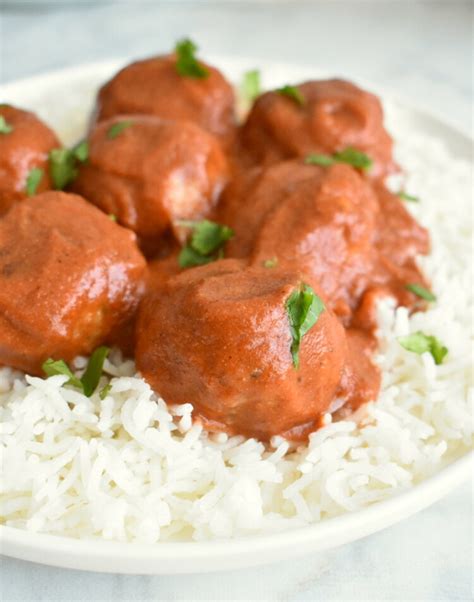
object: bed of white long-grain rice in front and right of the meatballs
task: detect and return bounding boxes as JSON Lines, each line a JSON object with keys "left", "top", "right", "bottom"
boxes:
{"left": 0, "top": 122, "right": 474, "bottom": 542}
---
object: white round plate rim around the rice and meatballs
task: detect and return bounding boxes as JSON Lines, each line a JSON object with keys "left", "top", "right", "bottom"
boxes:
{"left": 0, "top": 57, "right": 474, "bottom": 574}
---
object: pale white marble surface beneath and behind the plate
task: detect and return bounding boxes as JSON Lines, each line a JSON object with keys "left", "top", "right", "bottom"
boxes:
{"left": 0, "top": 0, "right": 473, "bottom": 602}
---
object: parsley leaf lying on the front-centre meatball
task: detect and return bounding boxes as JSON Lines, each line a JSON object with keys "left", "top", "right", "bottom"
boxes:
{"left": 286, "top": 283, "right": 326, "bottom": 368}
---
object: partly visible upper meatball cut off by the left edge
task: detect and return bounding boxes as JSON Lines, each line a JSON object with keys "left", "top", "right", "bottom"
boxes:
{"left": 0, "top": 104, "right": 60, "bottom": 215}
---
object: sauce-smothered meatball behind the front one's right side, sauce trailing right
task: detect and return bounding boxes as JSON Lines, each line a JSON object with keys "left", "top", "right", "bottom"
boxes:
{"left": 219, "top": 160, "right": 429, "bottom": 325}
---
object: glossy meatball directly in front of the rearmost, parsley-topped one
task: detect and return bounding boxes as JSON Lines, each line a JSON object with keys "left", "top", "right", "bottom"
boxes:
{"left": 72, "top": 115, "right": 231, "bottom": 251}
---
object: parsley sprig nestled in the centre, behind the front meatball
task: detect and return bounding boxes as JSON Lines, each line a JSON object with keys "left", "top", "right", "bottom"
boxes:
{"left": 177, "top": 220, "right": 234, "bottom": 268}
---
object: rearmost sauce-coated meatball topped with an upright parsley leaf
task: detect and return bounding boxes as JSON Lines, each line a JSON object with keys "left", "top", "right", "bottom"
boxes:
{"left": 97, "top": 54, "right": 235, "bottom": 136}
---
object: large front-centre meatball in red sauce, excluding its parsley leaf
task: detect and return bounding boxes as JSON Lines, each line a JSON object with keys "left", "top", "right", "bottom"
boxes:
{"left": 136, "top": 259, "right": 346, "bottom": 440}
